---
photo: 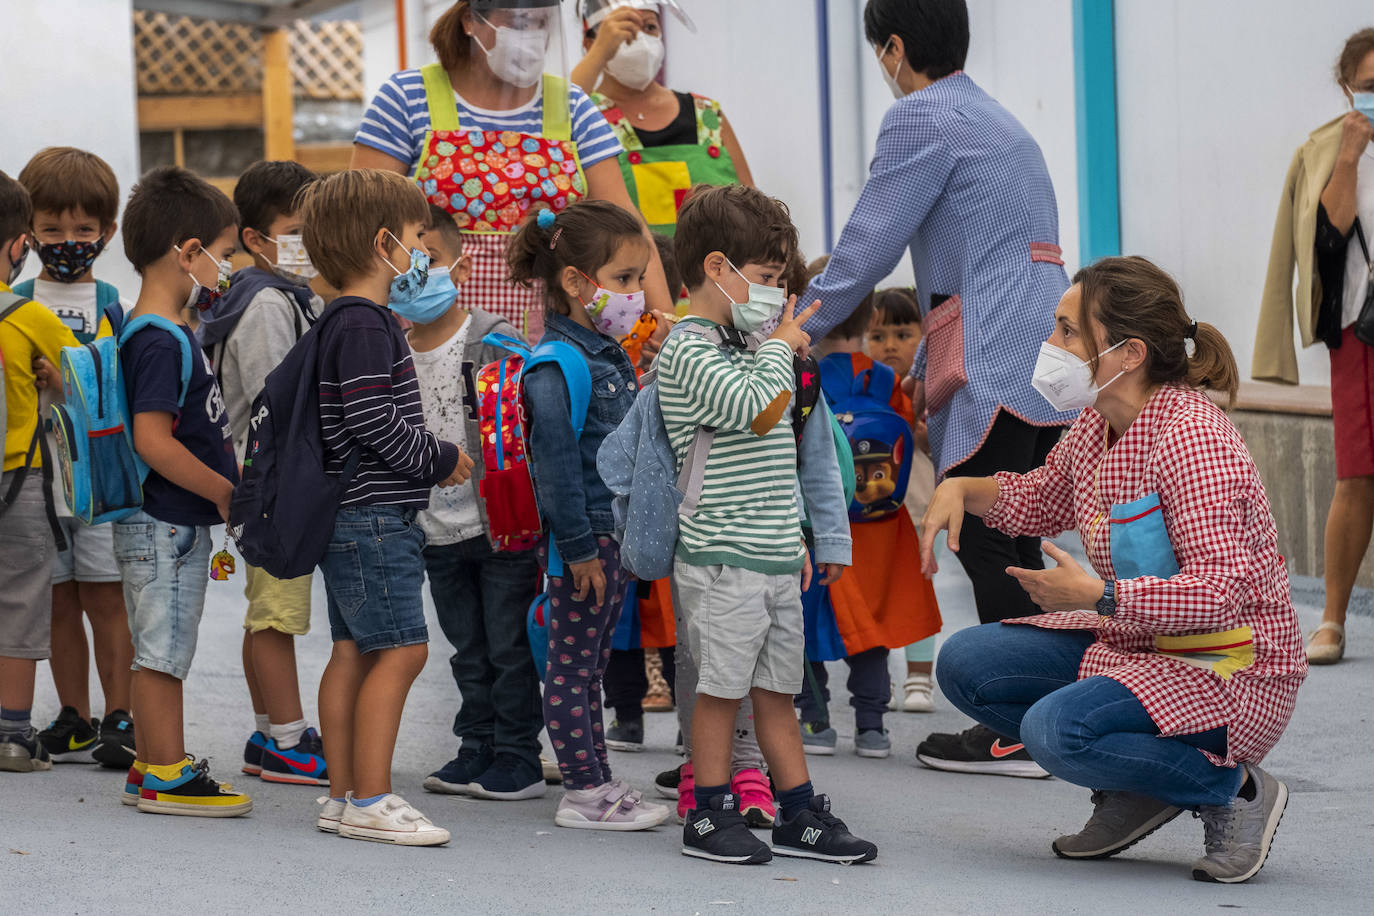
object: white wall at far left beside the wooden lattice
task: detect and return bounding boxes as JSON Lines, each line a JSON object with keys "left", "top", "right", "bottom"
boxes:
{"left": 0, "top": 0, "right": 139, "bottom": 298}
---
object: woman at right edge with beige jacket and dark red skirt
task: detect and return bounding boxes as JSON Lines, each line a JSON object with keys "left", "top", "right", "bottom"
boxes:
{"left": 1250, "top": 29, "right": 1374, "bottom": 665}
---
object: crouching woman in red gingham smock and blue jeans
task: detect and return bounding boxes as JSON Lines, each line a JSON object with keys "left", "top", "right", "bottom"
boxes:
{"left": 921, "top": 258, "right": 1307, "bottom": 883}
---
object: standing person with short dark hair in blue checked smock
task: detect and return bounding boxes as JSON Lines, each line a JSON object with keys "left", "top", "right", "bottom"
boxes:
{"left": 801, "top": 0, "right": 1073, "bottom": 776}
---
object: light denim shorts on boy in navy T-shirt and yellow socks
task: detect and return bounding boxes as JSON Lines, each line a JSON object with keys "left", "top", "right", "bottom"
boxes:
{"left": 114, "top": 512, "right": 210, "bottom": 680}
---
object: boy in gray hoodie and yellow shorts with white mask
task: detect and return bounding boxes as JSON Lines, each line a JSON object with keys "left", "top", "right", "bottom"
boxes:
{"left": 196, "top": 161, "right": 328, "bottom": 786}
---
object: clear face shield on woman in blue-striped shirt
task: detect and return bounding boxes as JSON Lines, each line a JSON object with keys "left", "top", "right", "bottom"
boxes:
{"left": 463, "top": 0, "right": 569, "bottom": 102}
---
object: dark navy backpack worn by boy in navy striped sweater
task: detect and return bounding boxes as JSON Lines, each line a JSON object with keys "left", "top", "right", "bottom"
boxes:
{"left": 229, "top": 302, "right": 372, "bottom": 578}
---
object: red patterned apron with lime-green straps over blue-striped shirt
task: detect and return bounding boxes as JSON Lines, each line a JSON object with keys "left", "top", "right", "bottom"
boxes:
{"left": 411, "top": 63, "right": 587, "bottom": 339}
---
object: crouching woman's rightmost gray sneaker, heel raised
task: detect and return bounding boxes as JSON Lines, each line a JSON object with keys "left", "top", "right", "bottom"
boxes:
{"left": 1193, "top": 764, "right": 1287, "bottom": 884}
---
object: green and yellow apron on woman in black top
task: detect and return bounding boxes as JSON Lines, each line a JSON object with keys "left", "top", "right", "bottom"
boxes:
{"left": 591, "top": 93, "right": 739, "bottom": 236}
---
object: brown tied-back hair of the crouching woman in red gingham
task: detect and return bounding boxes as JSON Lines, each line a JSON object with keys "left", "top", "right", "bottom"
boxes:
{"left": 1073, "top": 257, "right": 1241, "bottom": 407}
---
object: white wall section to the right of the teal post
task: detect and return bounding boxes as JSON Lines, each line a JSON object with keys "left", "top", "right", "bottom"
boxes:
{"left": 1116, "top": 0, "right": 1374, "bottom": 385}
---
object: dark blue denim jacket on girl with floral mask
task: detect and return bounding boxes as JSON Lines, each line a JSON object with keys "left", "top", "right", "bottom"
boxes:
{"left": 523, "top": 313, "right": 639, "bottom": 563}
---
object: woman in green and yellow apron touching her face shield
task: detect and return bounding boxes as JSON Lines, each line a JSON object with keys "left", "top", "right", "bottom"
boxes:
{"left": 573, "top": 0, "right": 753, "bottom": 236}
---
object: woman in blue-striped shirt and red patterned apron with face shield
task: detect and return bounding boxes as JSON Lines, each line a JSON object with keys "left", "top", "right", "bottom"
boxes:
{"left": 352, "top": 0, "right": 673, "bottom": 338}
